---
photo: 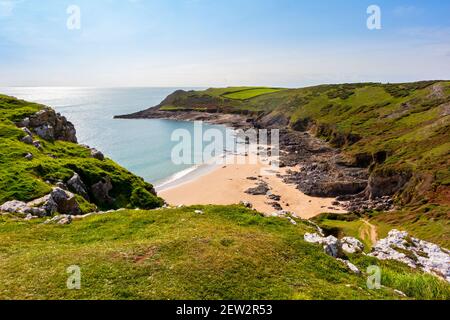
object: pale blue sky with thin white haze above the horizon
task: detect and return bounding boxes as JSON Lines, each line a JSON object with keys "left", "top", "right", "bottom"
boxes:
{"left": 0, "top": 0, "right": 450, "bottom": 87}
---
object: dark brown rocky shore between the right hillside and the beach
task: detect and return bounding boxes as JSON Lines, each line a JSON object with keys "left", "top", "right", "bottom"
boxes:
{"left": 115, "top": 106, "right": 394, "bottom": 213}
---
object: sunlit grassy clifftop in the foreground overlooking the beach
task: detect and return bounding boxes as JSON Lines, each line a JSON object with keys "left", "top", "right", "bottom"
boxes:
{"left": 0, "top": 206, "right": 450, "bottom": 299}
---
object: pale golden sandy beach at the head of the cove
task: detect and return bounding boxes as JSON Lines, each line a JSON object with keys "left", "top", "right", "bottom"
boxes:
{"left": 159, "top": 156, "right": 345, "bottom": 219}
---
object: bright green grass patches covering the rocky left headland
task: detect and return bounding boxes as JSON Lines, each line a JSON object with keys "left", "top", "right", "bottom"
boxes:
{"left": 0, "top": 95, "right": 161, "bottom": 212}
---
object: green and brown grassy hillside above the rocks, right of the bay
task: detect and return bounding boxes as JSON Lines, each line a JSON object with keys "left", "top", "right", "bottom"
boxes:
{"left": 156, "top": 81, "right": 450, "bottom": 247}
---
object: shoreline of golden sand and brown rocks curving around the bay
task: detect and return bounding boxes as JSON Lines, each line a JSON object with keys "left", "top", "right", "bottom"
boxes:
{"left": 120, "top": 107, "right": 368, "bottom": 219}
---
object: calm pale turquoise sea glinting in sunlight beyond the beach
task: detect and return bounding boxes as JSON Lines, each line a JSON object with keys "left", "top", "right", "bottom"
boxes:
{"left": 0, "top": 87, "right": 225, "bottom": 185}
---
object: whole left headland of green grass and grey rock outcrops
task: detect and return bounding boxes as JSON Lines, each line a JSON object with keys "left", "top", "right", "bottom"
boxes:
{"left": 0, "top": 95, "right": 163, "bottom": 220}
